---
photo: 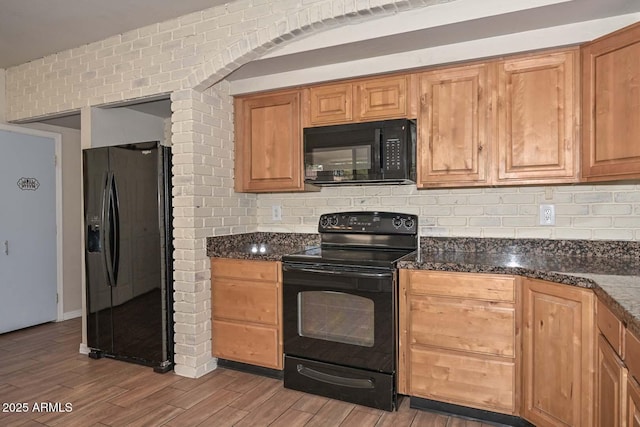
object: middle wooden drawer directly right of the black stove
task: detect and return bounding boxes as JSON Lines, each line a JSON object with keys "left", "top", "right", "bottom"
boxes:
{"left": 409, "top": 296, "right": 516, "bottom": 357}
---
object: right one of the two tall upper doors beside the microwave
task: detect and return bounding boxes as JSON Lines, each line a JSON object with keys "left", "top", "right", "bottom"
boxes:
{"left": 496, "top": 50, "right": 579, "bottom": 184}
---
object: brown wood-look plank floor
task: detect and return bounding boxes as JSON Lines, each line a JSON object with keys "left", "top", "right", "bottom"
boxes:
{"left": 0, "top": 319, "right": 500, "bottom": 427}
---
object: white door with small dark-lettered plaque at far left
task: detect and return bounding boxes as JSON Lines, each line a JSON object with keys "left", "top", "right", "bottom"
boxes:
{"left": 0, "top": 128, "right": 58, "bottom": 333}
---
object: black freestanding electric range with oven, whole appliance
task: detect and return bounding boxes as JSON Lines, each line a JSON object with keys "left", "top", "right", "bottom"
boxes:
{"left": 283, "top": 212, "right": 418, "bottom": 411}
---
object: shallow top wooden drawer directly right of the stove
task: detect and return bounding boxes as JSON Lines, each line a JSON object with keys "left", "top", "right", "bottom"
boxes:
{"left": 409, "top": 270, "right": 515, "bottom": 302}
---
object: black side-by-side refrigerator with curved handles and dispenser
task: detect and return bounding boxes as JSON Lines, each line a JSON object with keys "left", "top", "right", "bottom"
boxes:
{"left": 83, "top": 141, "right": 173, "bottom": 372}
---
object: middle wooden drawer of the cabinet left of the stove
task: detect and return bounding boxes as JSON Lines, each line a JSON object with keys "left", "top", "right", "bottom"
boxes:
{"left": 211, "top": 279, "right": 279, "bottom": 325}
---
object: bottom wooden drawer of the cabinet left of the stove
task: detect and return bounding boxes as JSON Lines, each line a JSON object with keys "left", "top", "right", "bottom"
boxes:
{"left": 213, "top": 320, "right": 282, "bottom": 369}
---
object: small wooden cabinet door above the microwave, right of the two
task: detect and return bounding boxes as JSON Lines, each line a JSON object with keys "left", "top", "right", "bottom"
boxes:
{"left": 355, "top": 76, "right": 407, "bottom": 121}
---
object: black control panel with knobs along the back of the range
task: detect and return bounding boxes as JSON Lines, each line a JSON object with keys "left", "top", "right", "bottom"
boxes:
{"left": 318, "top": 211, "right": 418, "bottom": 234}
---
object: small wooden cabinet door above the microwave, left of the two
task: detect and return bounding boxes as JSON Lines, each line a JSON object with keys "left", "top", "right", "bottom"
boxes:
{"left": 308, "top": 83, "right": 353, "bottom": 126}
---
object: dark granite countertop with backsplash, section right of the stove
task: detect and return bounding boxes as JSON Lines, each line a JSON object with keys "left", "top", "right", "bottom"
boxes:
{"left": 398, "top": 238, "right": 640, "bottom": 336}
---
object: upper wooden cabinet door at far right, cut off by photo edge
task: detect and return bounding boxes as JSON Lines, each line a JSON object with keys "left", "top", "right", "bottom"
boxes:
{"left": 582, "top": 23, "right": 640, "bottom": 181}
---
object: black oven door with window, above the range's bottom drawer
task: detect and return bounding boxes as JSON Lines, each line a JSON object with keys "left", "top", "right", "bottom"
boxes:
{"left": 283, "top": 263, "right": 397, "bottom": 373}
